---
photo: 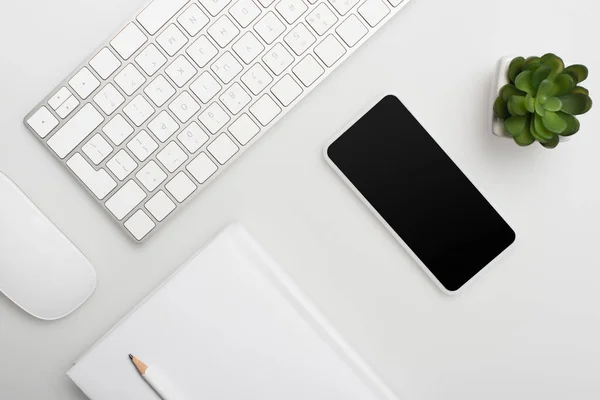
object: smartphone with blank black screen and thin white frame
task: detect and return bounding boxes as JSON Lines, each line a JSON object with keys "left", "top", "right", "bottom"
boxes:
{"left": 327, "top": 96, "right": 515, "bottom": 291}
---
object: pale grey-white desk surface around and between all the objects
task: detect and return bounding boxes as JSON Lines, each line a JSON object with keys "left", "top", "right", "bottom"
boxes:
{"left": 0, "top": 0, "right": 600, "bottom": 400}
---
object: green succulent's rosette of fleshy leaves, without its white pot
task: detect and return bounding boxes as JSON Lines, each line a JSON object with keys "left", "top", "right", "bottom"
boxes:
{"left": 494, "top": 54, "right": 592, "bottom": 149}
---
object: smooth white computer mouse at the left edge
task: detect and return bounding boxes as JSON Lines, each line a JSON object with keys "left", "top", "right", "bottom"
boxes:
{"left": 0, "top": 172, "right": 96, "bottom": 320}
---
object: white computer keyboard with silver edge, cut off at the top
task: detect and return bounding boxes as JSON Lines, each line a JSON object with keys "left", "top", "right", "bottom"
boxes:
{"left": 25, "top": 0, "right": 409, "bottom": 241}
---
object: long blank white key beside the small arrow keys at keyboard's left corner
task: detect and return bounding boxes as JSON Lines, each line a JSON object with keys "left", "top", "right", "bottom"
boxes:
{"left": 48, "top": 103, "right": 104, "bottom": 158}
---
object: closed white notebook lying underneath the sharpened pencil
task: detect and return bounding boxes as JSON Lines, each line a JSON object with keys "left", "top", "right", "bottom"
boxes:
{"left": 68, "top": 224, "right": 397, "bottom": 400}
